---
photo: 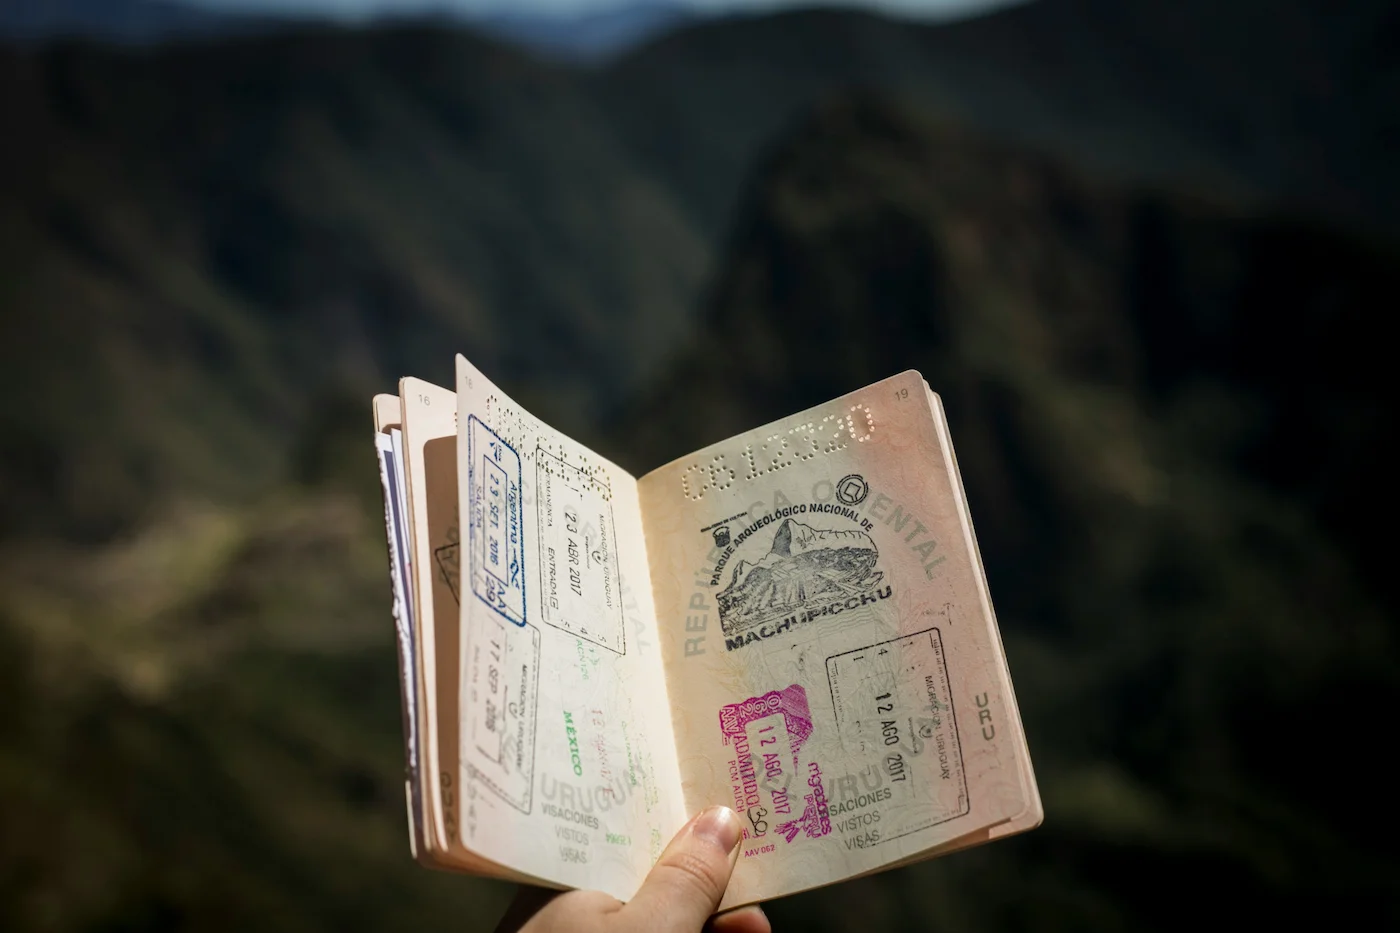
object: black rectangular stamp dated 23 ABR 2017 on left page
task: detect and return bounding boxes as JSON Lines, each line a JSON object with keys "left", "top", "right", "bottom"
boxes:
{"left": 535, "top": 447, "right": 627, "bottom": 654}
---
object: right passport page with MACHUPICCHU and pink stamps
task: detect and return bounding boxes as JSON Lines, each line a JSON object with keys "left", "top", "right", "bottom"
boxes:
{"left": 638, "top": 373, "right": 1033, "bottom": 908}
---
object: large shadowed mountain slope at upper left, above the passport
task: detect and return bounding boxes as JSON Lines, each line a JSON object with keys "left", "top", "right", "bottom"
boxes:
{"left": 0, "top": 29, "right": 707, "bottom": 532}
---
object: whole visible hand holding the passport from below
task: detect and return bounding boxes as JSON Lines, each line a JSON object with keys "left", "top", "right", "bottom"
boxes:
{"left": 496, "top": 807, "right": 771, "bottom": 933}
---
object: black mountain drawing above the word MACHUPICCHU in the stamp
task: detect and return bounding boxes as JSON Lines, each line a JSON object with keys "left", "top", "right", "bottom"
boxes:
{"left": 717, "top": 518, "right": 883, "bottom": 636}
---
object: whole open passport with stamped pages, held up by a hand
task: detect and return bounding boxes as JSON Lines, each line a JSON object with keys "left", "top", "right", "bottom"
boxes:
{"left": 374, "top": 356, "right": 1042, "bottom": 909}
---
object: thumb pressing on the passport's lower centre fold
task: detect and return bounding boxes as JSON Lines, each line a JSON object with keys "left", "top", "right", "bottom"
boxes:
{"left": 622, "top": 807, "right": 743, "bottom": 933}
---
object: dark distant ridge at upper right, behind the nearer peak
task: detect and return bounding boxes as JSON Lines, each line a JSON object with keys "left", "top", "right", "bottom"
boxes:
{"left": 601, "top": 0, "right": 1400, "bottom": 243}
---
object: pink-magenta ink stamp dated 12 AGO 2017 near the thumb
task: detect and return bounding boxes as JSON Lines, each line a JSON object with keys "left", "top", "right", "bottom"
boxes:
{"left": 720, "top": 684, "right": 832, "bottom": 855}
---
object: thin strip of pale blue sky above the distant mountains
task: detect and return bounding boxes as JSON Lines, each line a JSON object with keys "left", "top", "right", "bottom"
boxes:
{"left": 185, "top": 0, "right": 1016, "bottom": 20}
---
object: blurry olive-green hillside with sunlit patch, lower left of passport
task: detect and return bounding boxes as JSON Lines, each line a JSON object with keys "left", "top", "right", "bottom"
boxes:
{"left": 0, "top": 490, "right": 510, "bottom": 933}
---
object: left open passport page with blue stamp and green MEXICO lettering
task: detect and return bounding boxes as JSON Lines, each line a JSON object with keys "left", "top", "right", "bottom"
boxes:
{"left": 456, "top": 356, "right": 687, "bottom": 899}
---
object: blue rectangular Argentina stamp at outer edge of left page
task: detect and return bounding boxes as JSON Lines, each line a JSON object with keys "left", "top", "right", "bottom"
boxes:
{"left": 466, "top": 415, "right": 525, "bottom": 626}
